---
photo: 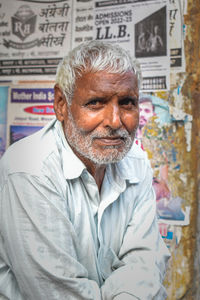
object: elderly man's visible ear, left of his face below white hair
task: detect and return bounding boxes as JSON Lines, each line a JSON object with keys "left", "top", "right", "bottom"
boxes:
{"left": 54, "top": 84, "right": 67, "bottom": 122}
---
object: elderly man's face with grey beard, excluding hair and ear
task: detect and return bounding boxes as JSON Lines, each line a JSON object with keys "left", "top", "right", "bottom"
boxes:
{"left": 63, "top": 71, "right": 139, "bottom": 164}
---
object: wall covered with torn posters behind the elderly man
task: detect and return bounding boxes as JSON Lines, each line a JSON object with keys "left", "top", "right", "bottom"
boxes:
{"left": 0, "top": 0, "right": 200, "bottom": 300}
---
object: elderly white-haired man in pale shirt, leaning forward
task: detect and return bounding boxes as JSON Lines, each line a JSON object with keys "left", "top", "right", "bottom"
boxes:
{"left": 0, "top": 41, "right": 169, "bottom": 300}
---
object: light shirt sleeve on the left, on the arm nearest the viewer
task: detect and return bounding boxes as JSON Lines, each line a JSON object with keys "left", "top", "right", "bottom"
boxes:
{"left": 0, "top": 173, "right": 101, "bottom": 300}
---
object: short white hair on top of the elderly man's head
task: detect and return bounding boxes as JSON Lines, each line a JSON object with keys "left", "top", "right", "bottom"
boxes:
{"left": 56, "top": 40, "right": 141, "bottom": 104}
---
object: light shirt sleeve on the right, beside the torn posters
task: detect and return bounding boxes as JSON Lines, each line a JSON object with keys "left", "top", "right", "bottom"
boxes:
{"left": 102, "top": 168, "right": 170, "bottom": 300}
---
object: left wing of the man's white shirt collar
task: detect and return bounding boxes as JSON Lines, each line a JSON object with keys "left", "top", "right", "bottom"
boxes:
{"left": 55, "top": 121, "right": 86, "bottom": 180}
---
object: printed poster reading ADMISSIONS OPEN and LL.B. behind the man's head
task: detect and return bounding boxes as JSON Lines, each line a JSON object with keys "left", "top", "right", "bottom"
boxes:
{"left": 94, "top": 0, "right": 170, "bottom": 91}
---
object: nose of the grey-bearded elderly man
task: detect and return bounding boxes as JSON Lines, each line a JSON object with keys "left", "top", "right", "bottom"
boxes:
{"left": 104, "top": 103, "right": 122, "bottom": 129}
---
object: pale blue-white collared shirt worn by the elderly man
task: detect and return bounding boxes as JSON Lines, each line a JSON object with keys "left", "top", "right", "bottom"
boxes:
{"left": 0, "top": 120, "right": 169, "bottom": 300}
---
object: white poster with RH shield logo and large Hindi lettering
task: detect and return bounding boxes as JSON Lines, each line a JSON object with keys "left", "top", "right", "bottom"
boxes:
{"left": 0, "top": 0, "right": 73, "bottom": 80}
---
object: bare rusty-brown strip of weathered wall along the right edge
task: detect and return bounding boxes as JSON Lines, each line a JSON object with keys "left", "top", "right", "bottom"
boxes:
{"left": 168, "top": 0, "right": 200, "bottom": 300}
